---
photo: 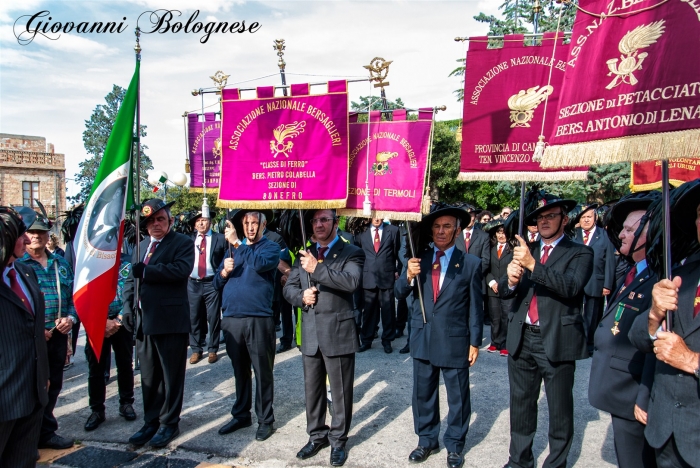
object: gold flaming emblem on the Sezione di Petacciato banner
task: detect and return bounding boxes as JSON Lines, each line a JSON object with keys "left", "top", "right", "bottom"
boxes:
{"left": 605, "top": 20, "right": 666, "bottom": 89}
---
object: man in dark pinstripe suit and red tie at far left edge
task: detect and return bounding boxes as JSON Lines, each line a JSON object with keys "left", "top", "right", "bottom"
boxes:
{"left": 0, "top": 206, "right": 49, "bottom": 468}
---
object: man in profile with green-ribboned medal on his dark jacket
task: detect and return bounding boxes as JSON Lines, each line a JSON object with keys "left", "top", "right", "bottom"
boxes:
{"left": 582, "top": 192, "right": 658, "bottom": 468}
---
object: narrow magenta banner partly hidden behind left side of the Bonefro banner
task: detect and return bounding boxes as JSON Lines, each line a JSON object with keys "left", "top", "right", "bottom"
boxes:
{"left": 187, "top": 112, "right": 221, "bottom": 189}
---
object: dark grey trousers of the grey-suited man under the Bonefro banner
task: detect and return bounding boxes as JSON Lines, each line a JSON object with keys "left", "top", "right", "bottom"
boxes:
{"left": 303, "top": 349, "right": 355, "bottom": 448}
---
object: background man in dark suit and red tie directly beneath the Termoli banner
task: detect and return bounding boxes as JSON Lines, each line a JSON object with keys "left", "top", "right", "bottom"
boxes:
{"left": 357, "top": 218, "right": 401, "bottom": 353}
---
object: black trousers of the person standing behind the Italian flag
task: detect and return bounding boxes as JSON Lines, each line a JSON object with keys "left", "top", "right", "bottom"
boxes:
{"left": 85, "top": 327, "right": 134, "bottom": 411}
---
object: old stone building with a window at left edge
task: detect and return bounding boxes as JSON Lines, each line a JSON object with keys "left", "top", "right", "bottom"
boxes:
{"left": 0, "top": 133, "right": 66, "bottom": 225}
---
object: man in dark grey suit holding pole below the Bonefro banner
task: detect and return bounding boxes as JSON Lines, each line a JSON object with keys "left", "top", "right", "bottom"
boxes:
{"left": 283, "top": 210, "right": 365, "bottom": 466}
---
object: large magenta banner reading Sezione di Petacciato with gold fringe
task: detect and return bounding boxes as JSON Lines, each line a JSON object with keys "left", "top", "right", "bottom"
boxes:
{"left": 542, "top": 0, "right": 700, "bottom": 167}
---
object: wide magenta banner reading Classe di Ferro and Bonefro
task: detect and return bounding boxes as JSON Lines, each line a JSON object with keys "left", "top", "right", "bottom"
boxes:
{"left": 217, "top": 81, "right": 348, "bottom": 209}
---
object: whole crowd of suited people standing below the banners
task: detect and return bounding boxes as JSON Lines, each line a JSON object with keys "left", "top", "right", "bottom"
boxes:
{"left": 0, "top": 180, "right": 700, "bottom": 468}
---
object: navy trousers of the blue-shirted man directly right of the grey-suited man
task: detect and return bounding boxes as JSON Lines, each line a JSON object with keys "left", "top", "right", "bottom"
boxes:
{"left": 412, "top": 358, "right": 472, "bottom": 453}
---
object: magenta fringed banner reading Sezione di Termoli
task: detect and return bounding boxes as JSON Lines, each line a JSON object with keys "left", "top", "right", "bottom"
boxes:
{"left": 338, "top": 114, "right": 433, "bottom": 221}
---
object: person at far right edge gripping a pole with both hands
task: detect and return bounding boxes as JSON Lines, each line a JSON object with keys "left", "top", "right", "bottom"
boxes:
{"left": 629, "top": 180, "right": 700, "bottom": 468}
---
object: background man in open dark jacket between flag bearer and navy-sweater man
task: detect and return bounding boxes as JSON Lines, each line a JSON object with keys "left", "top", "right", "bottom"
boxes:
{"left": 187, "top": 211, "right": 226, "bottom": 364}
